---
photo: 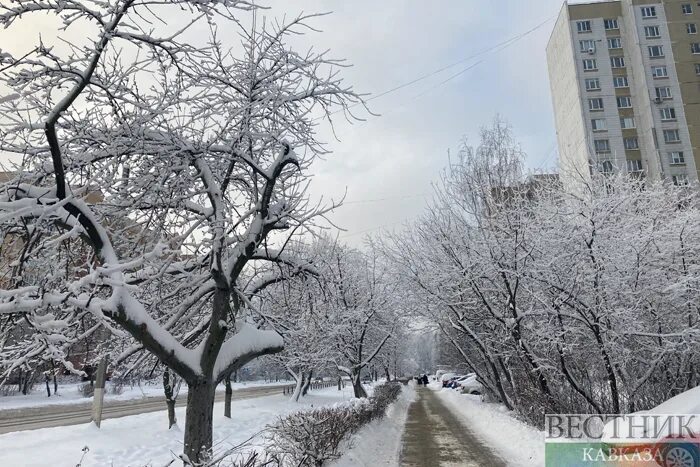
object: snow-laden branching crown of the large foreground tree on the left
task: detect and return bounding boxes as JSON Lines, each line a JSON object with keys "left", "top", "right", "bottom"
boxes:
{"left": 0, "top": 0, "right": 361, "bottom": 460}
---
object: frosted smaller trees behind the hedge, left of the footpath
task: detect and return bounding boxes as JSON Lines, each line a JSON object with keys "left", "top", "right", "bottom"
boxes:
{"left": 260, "top": 241, "right": 401, "bottom": 400}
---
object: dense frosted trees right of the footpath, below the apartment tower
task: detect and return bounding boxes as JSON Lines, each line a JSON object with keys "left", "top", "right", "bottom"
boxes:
{"left": 383, "top": 122, "right": 700, "bottom": 425}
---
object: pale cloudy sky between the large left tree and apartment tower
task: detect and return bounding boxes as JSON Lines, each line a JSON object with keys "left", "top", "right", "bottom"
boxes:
{"left": 0, "top": 0, "right": 562, "bottom": 245}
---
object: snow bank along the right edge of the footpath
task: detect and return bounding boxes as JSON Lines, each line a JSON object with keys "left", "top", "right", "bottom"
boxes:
{"left": 430, "top": 384, "right": 544, "bottom": 467}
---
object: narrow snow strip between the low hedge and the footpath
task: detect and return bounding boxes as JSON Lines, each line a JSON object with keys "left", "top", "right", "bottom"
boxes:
{"left": 331, "top": 382, "right": 416, "bottom": 467}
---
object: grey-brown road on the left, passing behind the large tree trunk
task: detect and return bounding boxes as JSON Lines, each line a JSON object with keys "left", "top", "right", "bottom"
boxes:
{"left": 0, "top": 386, "right": 290, "bottom": 434}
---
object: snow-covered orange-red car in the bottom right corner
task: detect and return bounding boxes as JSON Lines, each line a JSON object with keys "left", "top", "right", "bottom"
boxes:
{"left": 602, "top": 386, "right": 700, "bottom": 467}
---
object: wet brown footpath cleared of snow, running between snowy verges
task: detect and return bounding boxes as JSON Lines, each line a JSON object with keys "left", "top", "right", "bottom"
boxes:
{"left": 401, "top": 388, "right": 506, "bottom": 467}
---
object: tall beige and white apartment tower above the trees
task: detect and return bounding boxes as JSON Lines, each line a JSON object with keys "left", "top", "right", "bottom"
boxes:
{"left": 547, "top": 0, "right": 700, "bottom": 192}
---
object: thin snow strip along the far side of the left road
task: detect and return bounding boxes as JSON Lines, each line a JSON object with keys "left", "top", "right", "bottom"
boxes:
{"left": 0, "top": 381, "right": 293, "bottom": 411}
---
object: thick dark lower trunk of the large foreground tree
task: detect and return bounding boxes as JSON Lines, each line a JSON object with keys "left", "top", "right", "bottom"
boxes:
{"left": 185, "top": 381, "right": 216, "bottom": 463}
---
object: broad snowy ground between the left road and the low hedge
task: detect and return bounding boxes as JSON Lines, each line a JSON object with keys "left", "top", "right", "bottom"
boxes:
{"left": 0, "top": 385, "right": 353, "bottom": 467}
